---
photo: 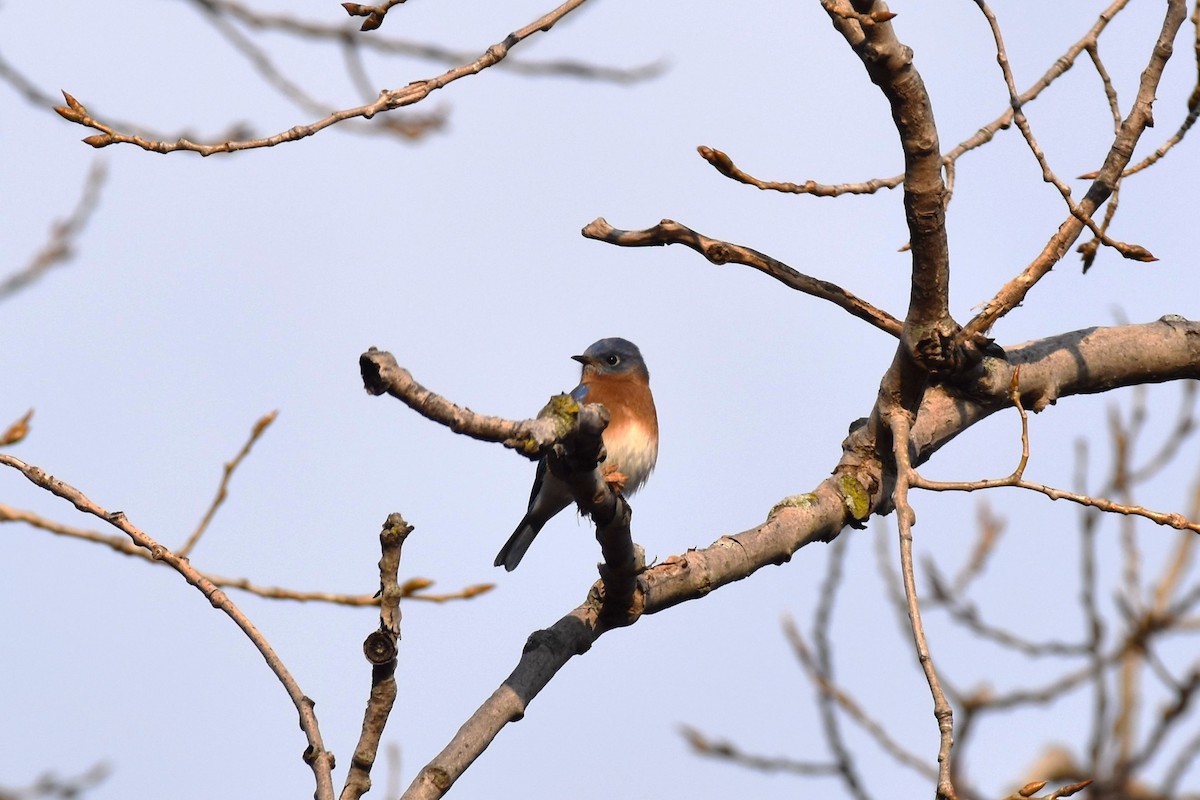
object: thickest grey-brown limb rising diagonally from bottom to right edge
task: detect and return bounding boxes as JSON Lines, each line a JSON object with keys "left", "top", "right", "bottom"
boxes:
{"left": 403, "top": 318, "right": 1200, "bottom": 800}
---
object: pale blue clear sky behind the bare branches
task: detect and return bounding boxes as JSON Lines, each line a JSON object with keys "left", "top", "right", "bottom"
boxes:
{"left": 0, "top": 0, "right": 1200, "bottom": 800}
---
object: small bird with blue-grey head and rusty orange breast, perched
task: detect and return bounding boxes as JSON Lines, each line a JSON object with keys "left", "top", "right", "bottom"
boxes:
{"left": 496, "top": 338, "right": 659, "bottom": 572}
